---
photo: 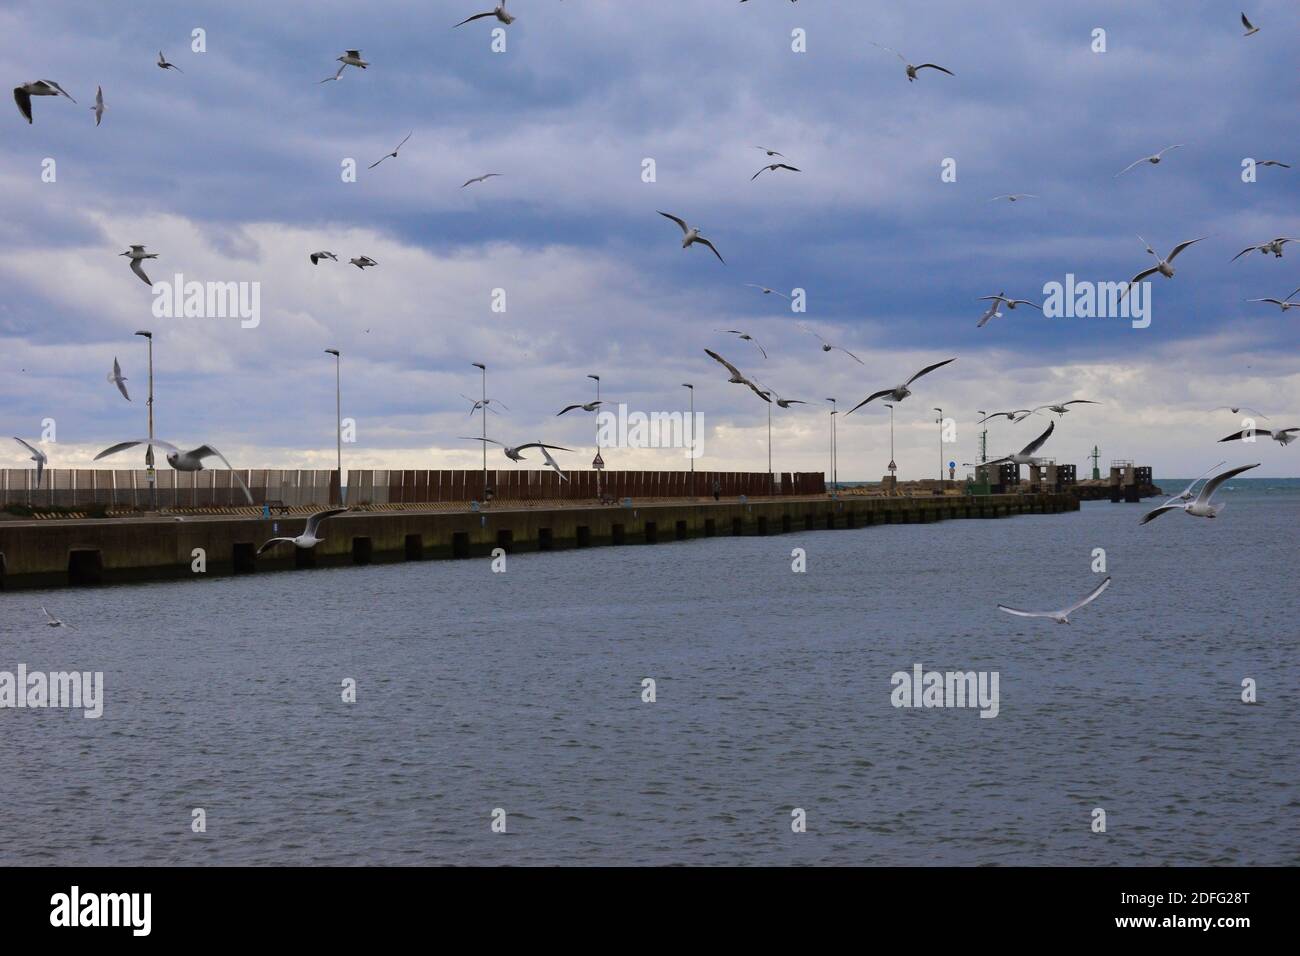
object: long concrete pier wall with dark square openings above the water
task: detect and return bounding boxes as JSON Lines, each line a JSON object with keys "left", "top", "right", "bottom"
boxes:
{"left": 0, "top": 493, "right": 1079, "bottom": 588}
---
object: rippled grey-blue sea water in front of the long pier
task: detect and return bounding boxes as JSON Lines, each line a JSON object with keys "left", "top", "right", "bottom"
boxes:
{"left": 0, "top": 481, "right": 1300, "bottom": 865}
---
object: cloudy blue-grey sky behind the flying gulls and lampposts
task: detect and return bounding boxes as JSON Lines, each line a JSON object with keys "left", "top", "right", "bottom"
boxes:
{"left": 0, "top": 0, "right": 1300, "bottom": 479}
